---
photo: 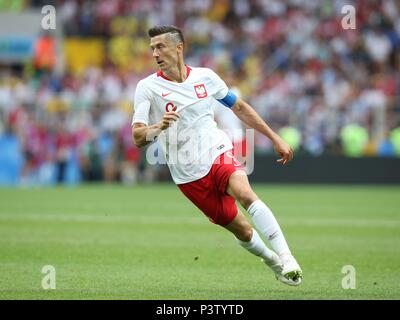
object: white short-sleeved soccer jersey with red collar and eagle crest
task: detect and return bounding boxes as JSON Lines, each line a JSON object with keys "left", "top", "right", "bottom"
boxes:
{"left": 132, "top": 67, "right": 232, "bottom": 184}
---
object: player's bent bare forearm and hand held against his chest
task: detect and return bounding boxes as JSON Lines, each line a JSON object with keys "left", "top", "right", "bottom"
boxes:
{"left": 132, "top": 111, "right": 179, "bottom": 148}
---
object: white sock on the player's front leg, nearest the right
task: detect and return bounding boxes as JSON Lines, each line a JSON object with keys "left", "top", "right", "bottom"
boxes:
{"left": 247, "top": 200, "right": 291, "bottom": 256}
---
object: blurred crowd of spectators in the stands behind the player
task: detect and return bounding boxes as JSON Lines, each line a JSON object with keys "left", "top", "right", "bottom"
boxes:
{"left": 0, "top": 0, "right": 400, "bottom": 183}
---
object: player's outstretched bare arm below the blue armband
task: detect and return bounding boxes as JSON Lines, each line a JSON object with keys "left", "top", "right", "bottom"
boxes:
{"left": 232, "top": 97, "right": 293, "bottom": 164}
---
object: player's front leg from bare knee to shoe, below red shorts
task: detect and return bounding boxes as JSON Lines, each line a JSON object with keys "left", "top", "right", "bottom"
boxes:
{"left": 227, "top": 170, "right": 302, "bottom": 280}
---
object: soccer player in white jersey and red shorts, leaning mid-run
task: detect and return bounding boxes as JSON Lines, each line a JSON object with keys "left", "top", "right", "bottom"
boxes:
{"left": 132, "top": 26, "right": 302, "bottom": 286}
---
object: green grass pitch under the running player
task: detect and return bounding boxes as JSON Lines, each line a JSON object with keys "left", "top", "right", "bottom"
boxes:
{"left": 0, "top": 184, "right": 400, "bottom": 300}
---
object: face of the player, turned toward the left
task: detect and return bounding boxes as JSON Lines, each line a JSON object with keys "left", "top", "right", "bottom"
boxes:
{"left": 150, "top": 34, "right": 180, "bottom": 71}
